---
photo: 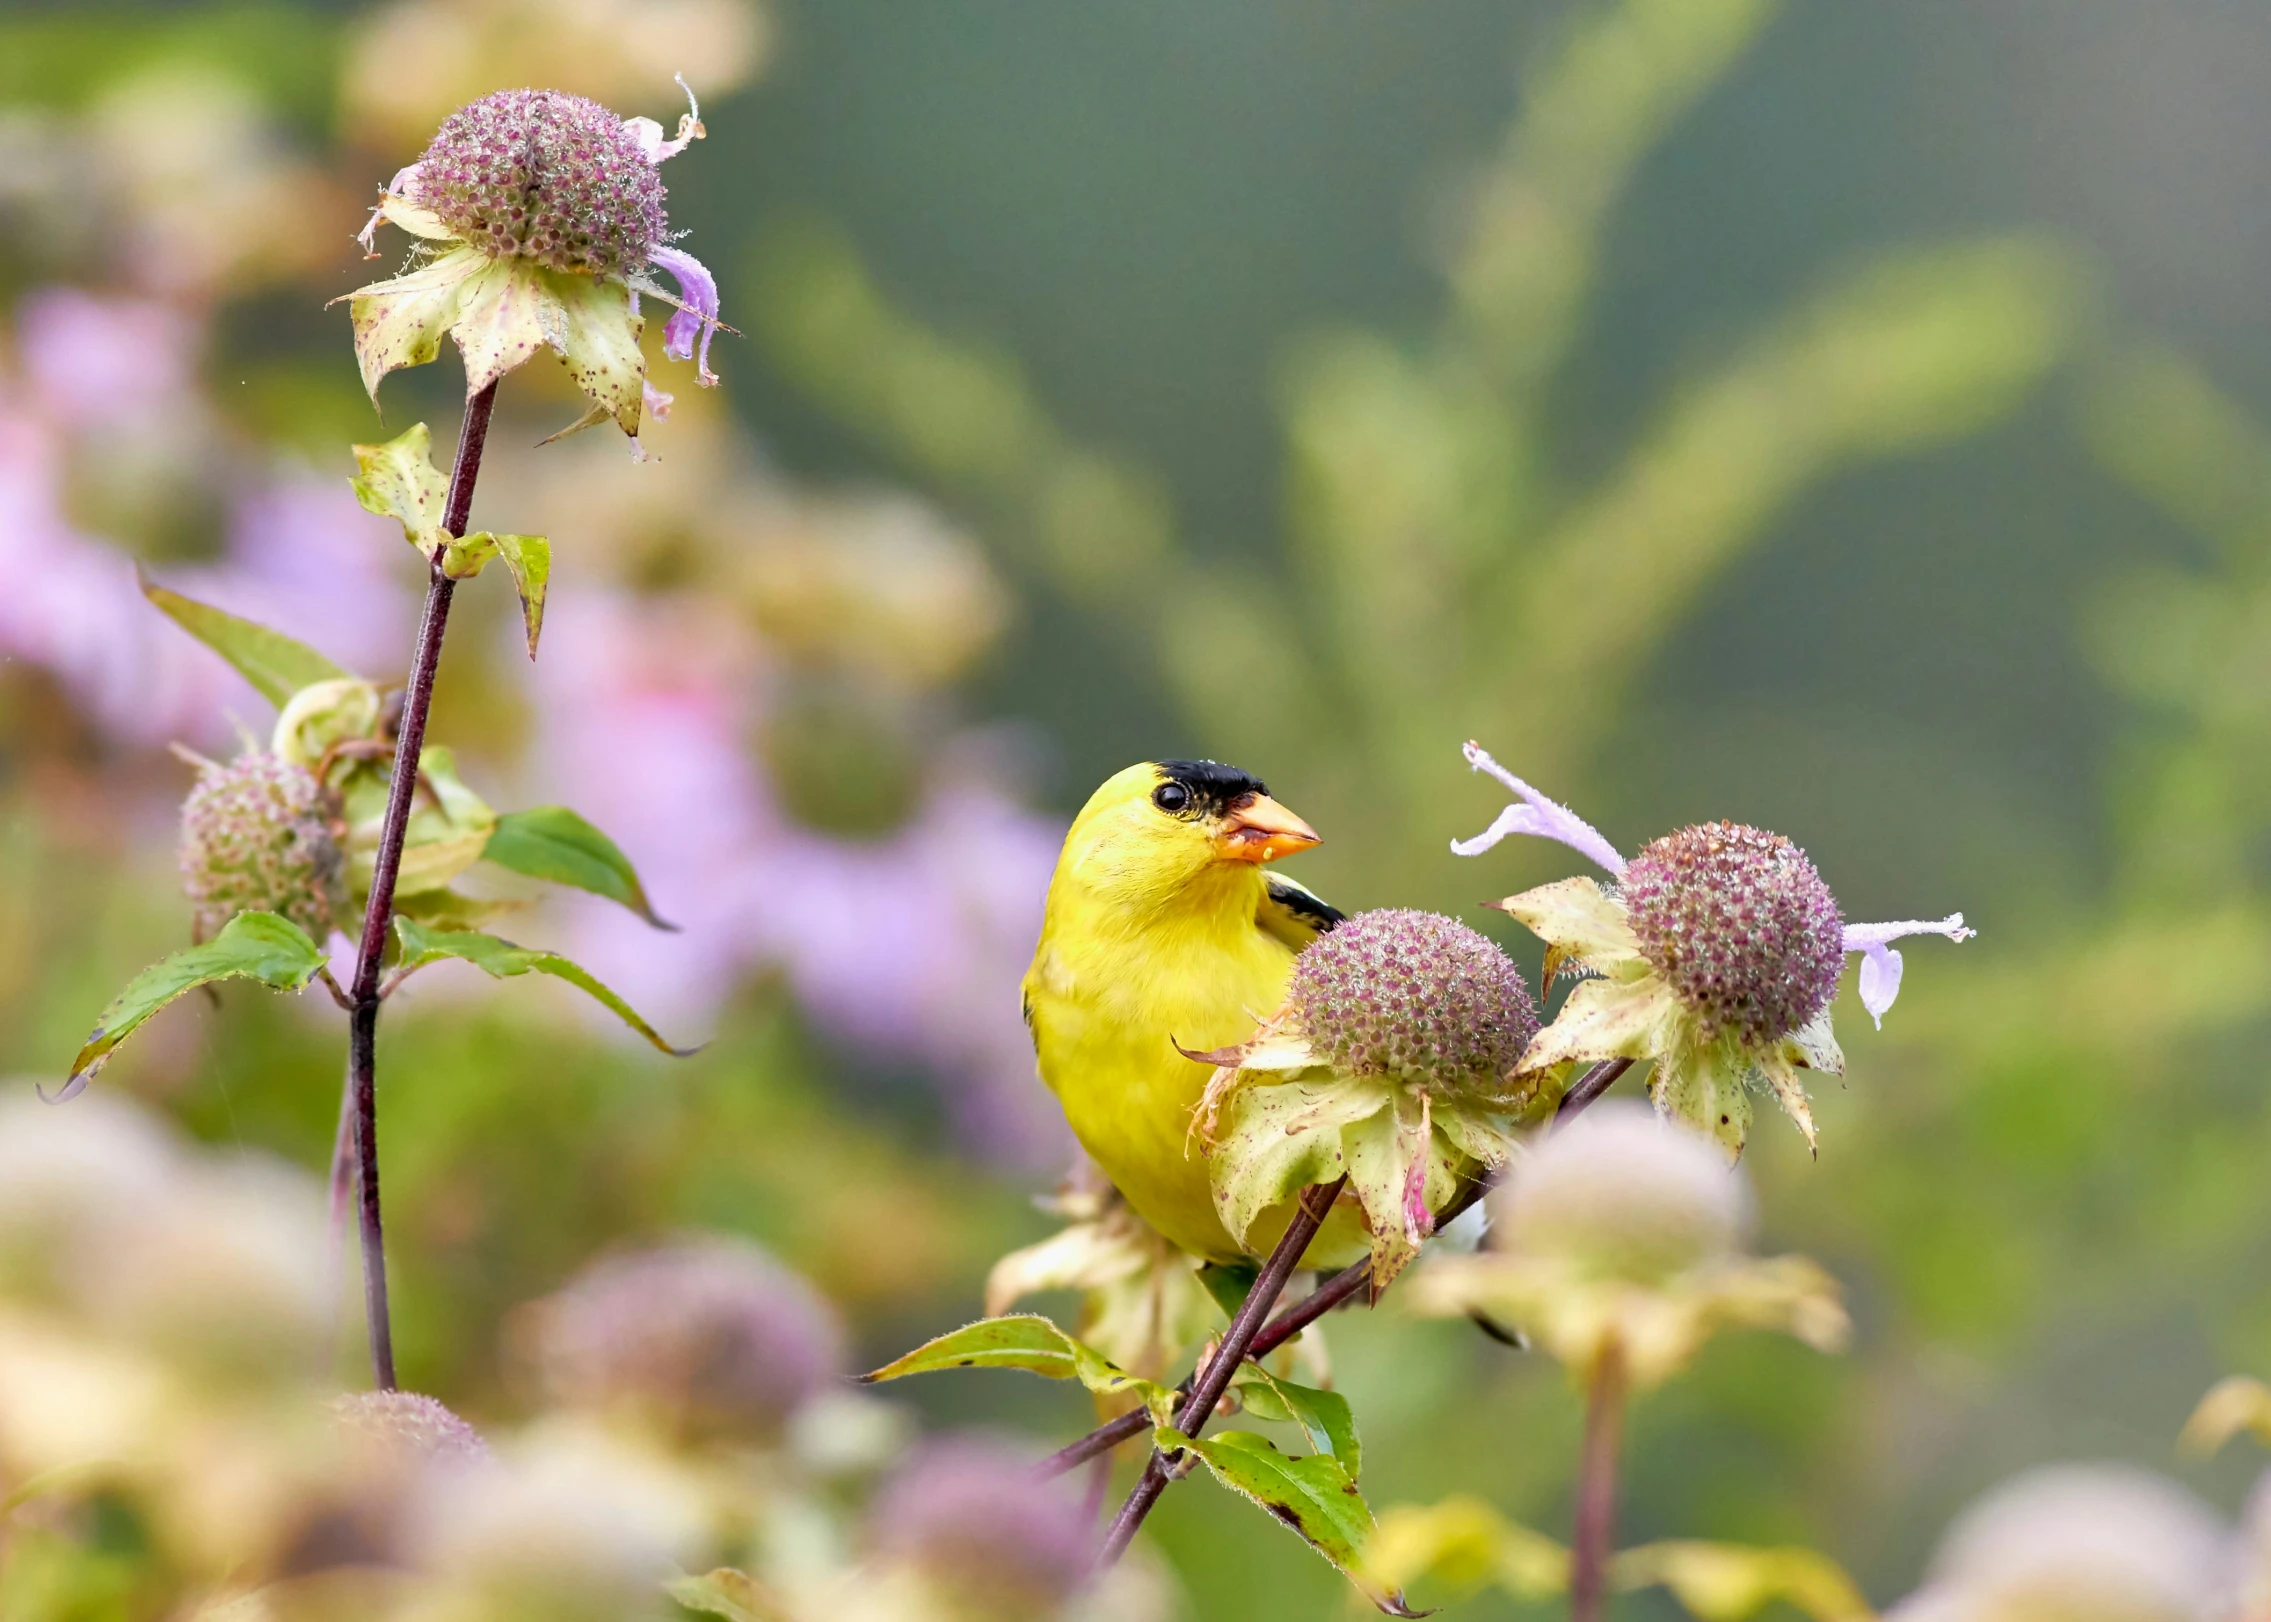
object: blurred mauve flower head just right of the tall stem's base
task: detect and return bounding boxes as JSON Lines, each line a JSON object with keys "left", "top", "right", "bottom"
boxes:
{"left": 529, "top": 1238, "right": 843, "bottom": 1440}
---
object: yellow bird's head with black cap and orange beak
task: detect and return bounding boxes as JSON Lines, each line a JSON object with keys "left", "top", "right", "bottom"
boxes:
{"left": 1058, "top": 761, "right": 1317, "bottom": 906}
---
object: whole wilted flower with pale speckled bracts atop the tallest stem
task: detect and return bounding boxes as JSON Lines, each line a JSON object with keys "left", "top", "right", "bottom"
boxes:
{"left": 347, "top": 80, "right": 718, "bottom": 443}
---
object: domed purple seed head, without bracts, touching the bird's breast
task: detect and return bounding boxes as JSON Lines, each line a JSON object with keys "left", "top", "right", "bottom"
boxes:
{"left": 1285, "top": 909, "right": 1537, "bottom": 1093}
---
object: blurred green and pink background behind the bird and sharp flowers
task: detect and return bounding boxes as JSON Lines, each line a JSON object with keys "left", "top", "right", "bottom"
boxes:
{"left": 0, "top": 0, "right": 2271, "bottom": 1617}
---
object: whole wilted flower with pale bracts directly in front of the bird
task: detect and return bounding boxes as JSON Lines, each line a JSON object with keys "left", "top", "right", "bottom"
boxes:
{"left": 1192, "top": 909, "right": 1537, "bottom": 1288}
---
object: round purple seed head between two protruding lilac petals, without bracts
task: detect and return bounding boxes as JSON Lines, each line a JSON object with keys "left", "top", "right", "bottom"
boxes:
{"left": 1624, "top": 822, "right": 1844, "bottom": 1047}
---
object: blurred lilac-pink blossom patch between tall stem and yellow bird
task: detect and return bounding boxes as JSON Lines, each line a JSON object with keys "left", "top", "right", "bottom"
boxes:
{"left": 536, "top": 595, "right": 1067, "bottom": 1165}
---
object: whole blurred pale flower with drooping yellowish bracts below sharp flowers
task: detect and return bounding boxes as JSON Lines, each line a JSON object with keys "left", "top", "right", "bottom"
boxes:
{"left": 1410, "top": 1100, "right": 1849, "bottom": 1386}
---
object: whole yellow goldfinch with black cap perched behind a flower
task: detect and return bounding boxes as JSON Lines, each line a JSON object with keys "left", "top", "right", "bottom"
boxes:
{"left": 1024, "top": 761, "right": 1367, "bottom": 1268}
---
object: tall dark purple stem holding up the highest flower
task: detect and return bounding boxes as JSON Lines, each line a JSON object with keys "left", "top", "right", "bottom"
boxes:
{"left": 347, "top": 384, "right": 497, "bottom": 1390}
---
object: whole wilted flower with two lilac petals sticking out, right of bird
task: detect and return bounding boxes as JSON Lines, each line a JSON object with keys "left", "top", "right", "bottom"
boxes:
{"left": 1451, "top": 743, "right": 1973, "bottom": 1154}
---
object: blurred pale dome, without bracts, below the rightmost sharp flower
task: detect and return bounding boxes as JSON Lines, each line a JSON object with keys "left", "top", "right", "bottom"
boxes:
{"left": 1492, "top": 1100, "right": 1751, "bottom": 1286}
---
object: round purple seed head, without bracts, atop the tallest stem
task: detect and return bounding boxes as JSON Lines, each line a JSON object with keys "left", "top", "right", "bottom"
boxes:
{"left": 413, "top": 91, "right": 665, "bottom": 275}
